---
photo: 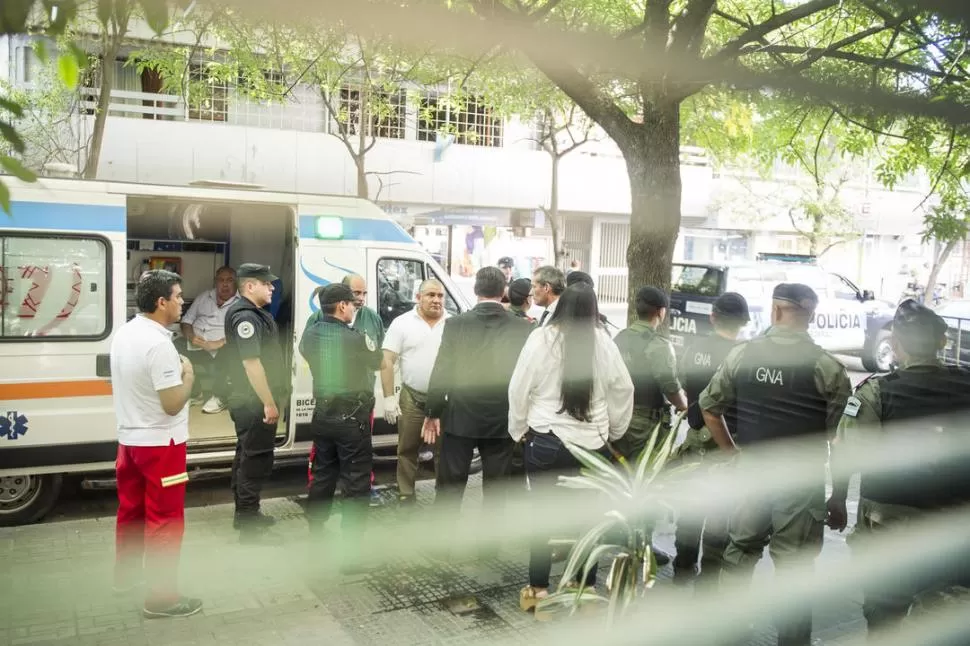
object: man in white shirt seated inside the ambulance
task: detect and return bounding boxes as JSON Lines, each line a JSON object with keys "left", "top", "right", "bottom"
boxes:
{"left": 182, "top": 266, "right": 239, "bottom": 414}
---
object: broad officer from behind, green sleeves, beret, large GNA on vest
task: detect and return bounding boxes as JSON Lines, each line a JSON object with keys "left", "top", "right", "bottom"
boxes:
{"left": 699, "top": 283, "right": 852, "bottom": 646}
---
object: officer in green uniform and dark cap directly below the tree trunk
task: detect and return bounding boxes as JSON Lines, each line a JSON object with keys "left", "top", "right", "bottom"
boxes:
{"left": 614, "top": 286, "right": 687, "bottom": 461}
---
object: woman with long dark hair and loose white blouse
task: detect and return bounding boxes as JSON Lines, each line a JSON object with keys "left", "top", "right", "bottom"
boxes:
{"left": 509, "top": 283, "right": 633, "bottom": 610}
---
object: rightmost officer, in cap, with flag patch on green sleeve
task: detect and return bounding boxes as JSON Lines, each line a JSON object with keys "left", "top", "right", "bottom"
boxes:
{"left": 828, "top": 300, "right": 970, "bottom": 643}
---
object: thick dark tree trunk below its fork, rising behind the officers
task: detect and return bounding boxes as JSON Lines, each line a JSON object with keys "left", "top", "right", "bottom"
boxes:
{"left": 617, "top": 103, "right": 681, "bottom": 321}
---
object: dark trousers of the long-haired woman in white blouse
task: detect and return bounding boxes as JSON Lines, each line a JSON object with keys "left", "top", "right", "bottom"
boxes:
{"left": 524, "top": 431, "right": 596, "bottom": 588}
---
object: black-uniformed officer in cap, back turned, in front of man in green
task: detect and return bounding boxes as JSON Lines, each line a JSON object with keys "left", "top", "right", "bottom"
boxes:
{"left": 300, "top": 284, "right": 383, "bottom": 546}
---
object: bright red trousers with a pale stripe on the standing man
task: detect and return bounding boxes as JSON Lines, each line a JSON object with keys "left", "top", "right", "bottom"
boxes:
{"left": 115, "top": 442, "right": 189, "bottom": 607}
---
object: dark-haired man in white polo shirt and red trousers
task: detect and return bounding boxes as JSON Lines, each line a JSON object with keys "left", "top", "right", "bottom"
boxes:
{"left": 111, "top": 270, "right": 202, "bottom": 619}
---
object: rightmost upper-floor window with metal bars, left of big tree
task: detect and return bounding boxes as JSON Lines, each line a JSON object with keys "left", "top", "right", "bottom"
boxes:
{"left": 418, "top": 95, "right": 502, "bottom": 148}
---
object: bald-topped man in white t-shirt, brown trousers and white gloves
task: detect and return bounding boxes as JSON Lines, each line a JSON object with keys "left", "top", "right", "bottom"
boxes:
{"left": 381, "top": 280, "right": 448, "bottom": 504}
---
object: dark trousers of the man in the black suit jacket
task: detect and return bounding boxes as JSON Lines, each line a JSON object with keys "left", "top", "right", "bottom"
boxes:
{"left": 435, "top": 433, "right": 515, "bottom": 522}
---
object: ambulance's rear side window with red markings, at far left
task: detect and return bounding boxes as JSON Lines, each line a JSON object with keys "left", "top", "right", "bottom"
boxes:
{"left": 0, "top": 236, "right": 111, "bottom": 339}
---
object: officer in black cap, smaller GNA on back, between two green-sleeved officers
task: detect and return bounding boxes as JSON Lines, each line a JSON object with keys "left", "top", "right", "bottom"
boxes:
{"left": 674, "top": 292, "right": 751, "bottom": 583}
